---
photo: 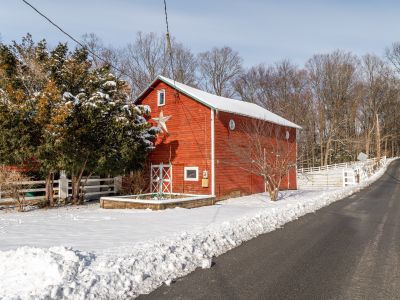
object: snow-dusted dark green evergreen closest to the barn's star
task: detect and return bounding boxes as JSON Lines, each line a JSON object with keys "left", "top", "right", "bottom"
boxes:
{"left": 56, "top": 67, "right": 158, "bottom": 203}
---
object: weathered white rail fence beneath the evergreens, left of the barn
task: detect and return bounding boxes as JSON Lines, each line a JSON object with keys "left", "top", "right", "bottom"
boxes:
{"left": 0, "top": 175, "right": 121, "bottom": 205}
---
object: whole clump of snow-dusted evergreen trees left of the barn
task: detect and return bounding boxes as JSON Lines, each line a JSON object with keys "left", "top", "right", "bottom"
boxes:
{"left": 0, "top": 35, "right": 158, "bottom": 205}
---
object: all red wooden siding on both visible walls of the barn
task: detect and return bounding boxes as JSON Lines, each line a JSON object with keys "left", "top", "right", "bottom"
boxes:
{"left": 139, "top": 81, "right": 297, "bottom": 196}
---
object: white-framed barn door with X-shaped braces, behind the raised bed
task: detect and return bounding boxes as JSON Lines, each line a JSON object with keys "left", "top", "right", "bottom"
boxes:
{"left": 150, "top": 163, "right": 172, "bottom": 194}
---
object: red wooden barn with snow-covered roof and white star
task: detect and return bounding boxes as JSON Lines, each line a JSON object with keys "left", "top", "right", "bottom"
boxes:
{"left": 136, "top": 76, "right": 300, "bottom": 197}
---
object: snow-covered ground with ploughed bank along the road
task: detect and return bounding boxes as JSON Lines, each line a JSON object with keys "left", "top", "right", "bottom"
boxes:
{"left": 0, "top": 161, "right": 394, "bottom": 299}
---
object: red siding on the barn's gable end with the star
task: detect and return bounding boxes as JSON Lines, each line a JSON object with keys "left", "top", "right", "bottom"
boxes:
{"left": 140, "top": 82, "right": 212, "bottom": 195}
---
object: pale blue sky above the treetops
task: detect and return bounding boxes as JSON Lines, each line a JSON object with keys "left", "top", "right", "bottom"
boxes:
{"left": 0, "top": 0, "right": 400, "bottom": 66}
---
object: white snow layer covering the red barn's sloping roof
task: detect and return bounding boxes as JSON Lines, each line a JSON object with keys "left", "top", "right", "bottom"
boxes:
{"left": 139, "top": 75, "right": 301, "bottom": 129}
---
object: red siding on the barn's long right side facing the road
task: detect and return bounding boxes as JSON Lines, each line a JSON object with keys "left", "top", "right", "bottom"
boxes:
{"left": 215, "top": 112, "right": 297, "bottom": 196}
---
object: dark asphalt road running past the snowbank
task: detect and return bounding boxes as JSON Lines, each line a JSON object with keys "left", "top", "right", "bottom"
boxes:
{"left": 139, "top": 160, "right": 400, "bottom": 300}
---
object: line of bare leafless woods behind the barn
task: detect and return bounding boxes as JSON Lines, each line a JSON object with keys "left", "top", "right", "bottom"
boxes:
{"left": 85, "top": 33, "right": 400, "bottom": 167}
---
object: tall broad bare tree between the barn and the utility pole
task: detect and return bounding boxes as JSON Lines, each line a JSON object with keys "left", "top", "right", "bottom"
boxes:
{"left": 307, "top": 51, "right": 359, "bottom": 165}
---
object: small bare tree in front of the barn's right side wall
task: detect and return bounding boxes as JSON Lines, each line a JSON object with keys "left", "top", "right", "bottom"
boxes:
{"left": 227, "top": 119, "right": 296, "bottom": 201}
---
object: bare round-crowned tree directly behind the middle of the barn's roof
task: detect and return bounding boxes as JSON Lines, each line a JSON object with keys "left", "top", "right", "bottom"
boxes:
{"left": 198, "top": 47, "right": 242, "bottom": 97}
